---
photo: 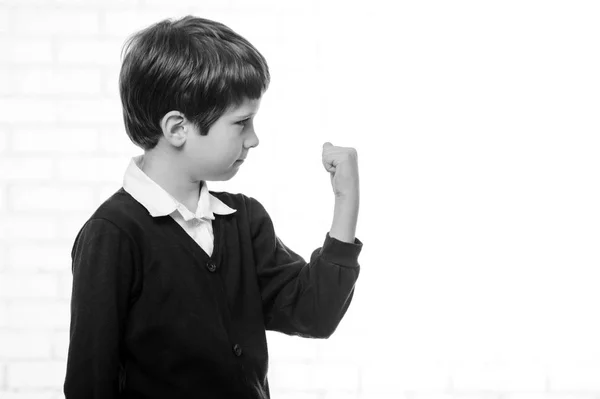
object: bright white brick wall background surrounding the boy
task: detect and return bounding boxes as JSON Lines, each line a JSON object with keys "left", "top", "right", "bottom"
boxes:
{"left": 0, "top": 0, "right": 600, "bottom": 399}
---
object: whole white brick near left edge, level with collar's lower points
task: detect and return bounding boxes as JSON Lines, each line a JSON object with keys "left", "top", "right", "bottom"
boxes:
{"left": 8, "top": 184, "right": 94, "bottom": 212}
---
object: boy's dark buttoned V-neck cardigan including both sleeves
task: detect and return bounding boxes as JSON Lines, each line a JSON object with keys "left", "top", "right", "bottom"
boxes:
{"left": 64, "top": 188, "right": 362, "bottom": 399}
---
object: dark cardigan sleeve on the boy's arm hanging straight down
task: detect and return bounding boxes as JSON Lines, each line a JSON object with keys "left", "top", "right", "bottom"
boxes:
{"left": 64, "top": 219, "right": 135, "bottom": 399}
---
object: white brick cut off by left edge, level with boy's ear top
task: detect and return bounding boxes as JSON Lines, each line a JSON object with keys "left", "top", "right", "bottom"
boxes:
{"left": 0, "top": 98, "right": 59, "bottom": 124}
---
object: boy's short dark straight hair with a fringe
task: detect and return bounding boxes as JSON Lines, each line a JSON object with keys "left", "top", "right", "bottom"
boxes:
{"left": 119, "top": 15, "right": 270, "bottom": 150}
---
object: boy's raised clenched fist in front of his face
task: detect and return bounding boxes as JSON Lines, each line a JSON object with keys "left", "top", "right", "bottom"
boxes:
{"left": 323, "top": 142, "right": 360, "bottom": 198}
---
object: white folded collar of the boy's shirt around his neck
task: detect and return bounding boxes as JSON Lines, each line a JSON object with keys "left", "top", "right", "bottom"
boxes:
{"left": 123, "top": 155, "right": 236, "bottom": 221}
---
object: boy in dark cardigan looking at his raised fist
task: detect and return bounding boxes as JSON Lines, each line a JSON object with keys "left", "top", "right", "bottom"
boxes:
{"left": 64, "top": 16, "right": 362, "bottom": 399}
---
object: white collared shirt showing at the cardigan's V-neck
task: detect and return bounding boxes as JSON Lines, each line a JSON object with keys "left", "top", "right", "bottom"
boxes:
{"left": 123, "top": 155, "right": 236, "bottom": 256}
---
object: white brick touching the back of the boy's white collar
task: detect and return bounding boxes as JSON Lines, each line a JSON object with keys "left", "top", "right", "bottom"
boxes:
{"left": 57, "top": 156, "right": 129, "bottom": 185}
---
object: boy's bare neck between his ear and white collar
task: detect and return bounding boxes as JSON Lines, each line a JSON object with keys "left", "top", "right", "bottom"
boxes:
{"left": 140, "top": 149, "right": 202, "bottom": 212}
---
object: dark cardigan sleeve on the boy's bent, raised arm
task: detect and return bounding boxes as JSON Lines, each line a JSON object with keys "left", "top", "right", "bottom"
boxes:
{"left": 250, "top": 198, "right": 362, "bottom": 338}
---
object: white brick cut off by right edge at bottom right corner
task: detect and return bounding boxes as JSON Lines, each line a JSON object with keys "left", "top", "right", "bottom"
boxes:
{"left": 548, "top": 364, "right": 600, "bottom": 392}
